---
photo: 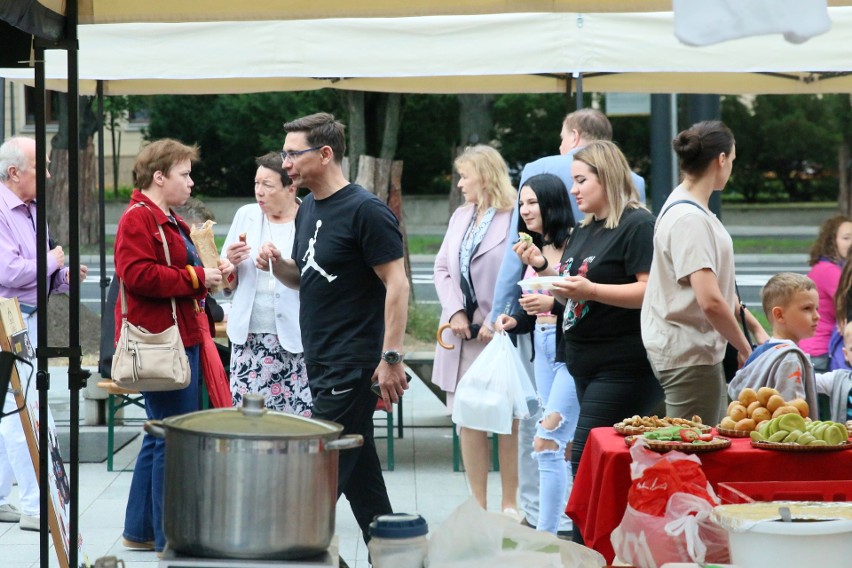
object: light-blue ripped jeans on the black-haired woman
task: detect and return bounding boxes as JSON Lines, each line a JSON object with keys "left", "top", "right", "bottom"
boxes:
{"left": 533, "top": 323, "right": 580, "bottom": 534}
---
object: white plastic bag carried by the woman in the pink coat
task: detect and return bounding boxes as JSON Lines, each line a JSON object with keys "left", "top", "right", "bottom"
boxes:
{"left": 453, "top": 333, "right": 536, "bottom": 434}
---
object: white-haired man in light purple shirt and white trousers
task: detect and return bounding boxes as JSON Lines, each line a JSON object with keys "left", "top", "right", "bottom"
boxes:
{"left": 0, "top": 136, "right": 88, "bottom": 531}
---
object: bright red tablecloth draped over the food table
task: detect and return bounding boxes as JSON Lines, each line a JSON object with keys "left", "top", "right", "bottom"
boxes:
{"left": 566, "top": 427, "right": 852, "bottom": 562}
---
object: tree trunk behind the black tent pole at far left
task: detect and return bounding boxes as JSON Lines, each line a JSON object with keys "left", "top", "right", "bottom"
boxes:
{"left": 47, "top": 95, "right": 100, "bottom": 246}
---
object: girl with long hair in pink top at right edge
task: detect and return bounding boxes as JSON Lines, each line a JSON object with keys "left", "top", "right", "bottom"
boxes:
{"left": 799, "top": 215, "right": 852, "bottom": 373}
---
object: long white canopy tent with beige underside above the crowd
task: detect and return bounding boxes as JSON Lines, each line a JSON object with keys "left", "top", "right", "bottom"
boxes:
{"left": 5, "top": 7, "right": 852, "bottom": 95}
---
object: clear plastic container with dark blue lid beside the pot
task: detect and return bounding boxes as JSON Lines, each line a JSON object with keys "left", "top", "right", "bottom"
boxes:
{"left": 367, "top": 513, "right": 429, "bottom": 568}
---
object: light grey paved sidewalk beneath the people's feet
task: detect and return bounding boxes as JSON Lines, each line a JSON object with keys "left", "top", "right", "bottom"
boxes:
{"left": 0, "top": 368, "right": 500, "bottom": 568}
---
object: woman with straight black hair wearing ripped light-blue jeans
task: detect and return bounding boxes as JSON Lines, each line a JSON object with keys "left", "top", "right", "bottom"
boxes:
{"left": 495, "top": 174, "right": 580, "bottom": 534}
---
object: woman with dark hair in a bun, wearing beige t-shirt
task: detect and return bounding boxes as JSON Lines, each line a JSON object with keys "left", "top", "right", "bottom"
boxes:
{"left": 642, "top": 120, "right": 768, "bottom": 424}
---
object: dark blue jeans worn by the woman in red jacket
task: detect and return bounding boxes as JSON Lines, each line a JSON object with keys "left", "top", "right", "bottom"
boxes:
{"left": 123, "top": 345, "right": 201, "bottom": 552}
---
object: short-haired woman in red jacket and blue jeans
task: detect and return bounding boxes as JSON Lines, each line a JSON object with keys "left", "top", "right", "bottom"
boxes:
{"left": 115, "top": 139, "right": 233, "bottom": 552}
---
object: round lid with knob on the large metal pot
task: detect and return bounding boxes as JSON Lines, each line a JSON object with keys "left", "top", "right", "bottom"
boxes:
{"left": 163, "top": 394, "right": 343, "bottom": 439}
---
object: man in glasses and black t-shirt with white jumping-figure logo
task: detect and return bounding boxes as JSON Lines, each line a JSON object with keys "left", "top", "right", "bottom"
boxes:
{"left": 257, "top": 113, "right": 409, "bottom": 541}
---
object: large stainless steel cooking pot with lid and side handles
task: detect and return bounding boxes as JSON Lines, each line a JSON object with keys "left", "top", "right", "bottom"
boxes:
{"left": 145, "top": 395, "right": 364, "bottom": 559}
